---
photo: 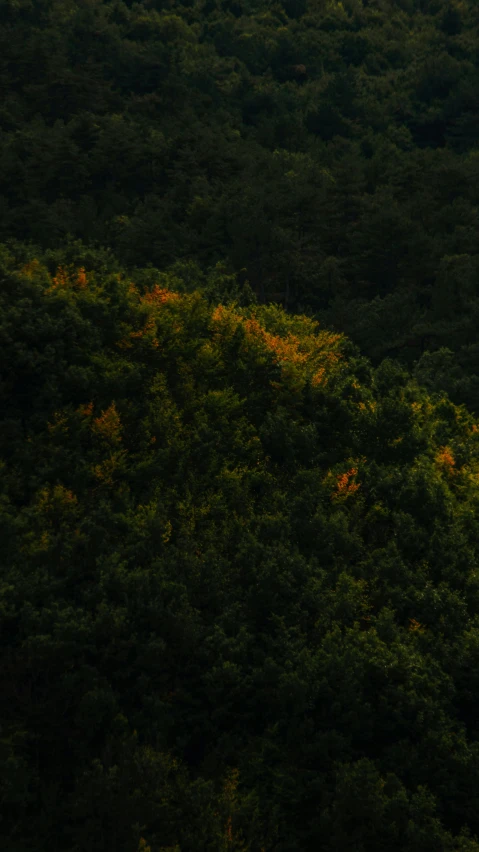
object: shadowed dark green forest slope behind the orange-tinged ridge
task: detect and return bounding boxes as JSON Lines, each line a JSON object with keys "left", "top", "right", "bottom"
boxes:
{"left": 0, "top": 0, "right": 479, "bottom": 411}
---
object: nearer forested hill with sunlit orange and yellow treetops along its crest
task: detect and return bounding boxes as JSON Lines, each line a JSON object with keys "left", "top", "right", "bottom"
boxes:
{"left": 0, "top": 249, "right": 479, "bottom": 852}
